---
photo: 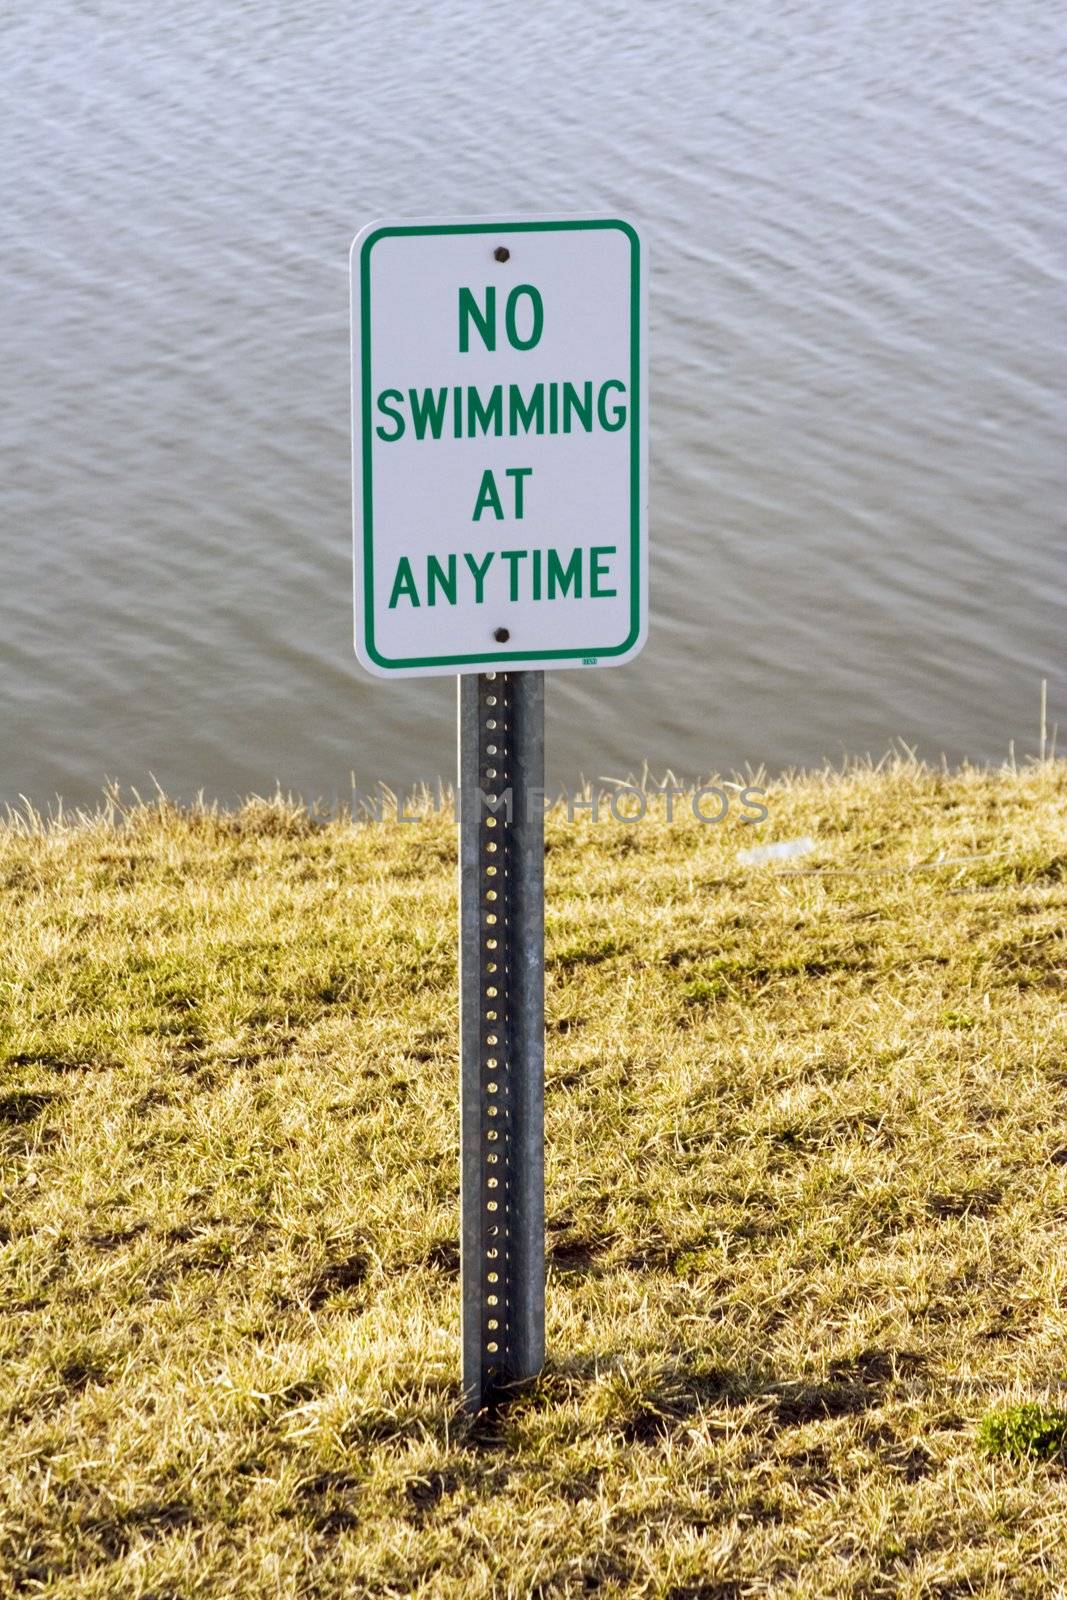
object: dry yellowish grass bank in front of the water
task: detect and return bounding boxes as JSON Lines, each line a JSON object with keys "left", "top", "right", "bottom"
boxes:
{"left": 0, "top": 762, "right": 1067, "bottom": 1600}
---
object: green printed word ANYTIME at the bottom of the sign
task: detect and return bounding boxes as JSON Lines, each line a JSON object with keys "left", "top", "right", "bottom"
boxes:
{"left": 389, "top": 544, "right": 616, "bottom": 611}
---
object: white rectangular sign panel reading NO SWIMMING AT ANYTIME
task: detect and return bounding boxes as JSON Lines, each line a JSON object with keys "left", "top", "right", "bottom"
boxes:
{"left": 352, "top": 218, "right": 648, "bottom": 678}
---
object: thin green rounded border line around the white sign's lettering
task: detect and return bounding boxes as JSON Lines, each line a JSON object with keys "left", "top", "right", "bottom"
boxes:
{"left": 360, "top": 218, "right": 645, "bottom": 670}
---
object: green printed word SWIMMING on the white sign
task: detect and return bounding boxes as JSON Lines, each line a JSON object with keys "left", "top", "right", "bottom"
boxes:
{"left": 374, "top": 378, "right": 627, "bottom": 445}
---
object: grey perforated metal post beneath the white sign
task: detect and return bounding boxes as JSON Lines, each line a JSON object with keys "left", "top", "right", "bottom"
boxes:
{"left": 459, "top": 672, "right": 544, "bottom": 1410}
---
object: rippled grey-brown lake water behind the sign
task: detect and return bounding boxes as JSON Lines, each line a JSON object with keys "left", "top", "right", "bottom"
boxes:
{"left": 0, "top": 0, "right": 1067, "bottom": 803}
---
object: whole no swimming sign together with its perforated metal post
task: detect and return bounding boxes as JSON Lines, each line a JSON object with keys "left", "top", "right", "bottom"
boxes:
{"left": 352, "top": 216, "right": 648, "bottom": 1408}
